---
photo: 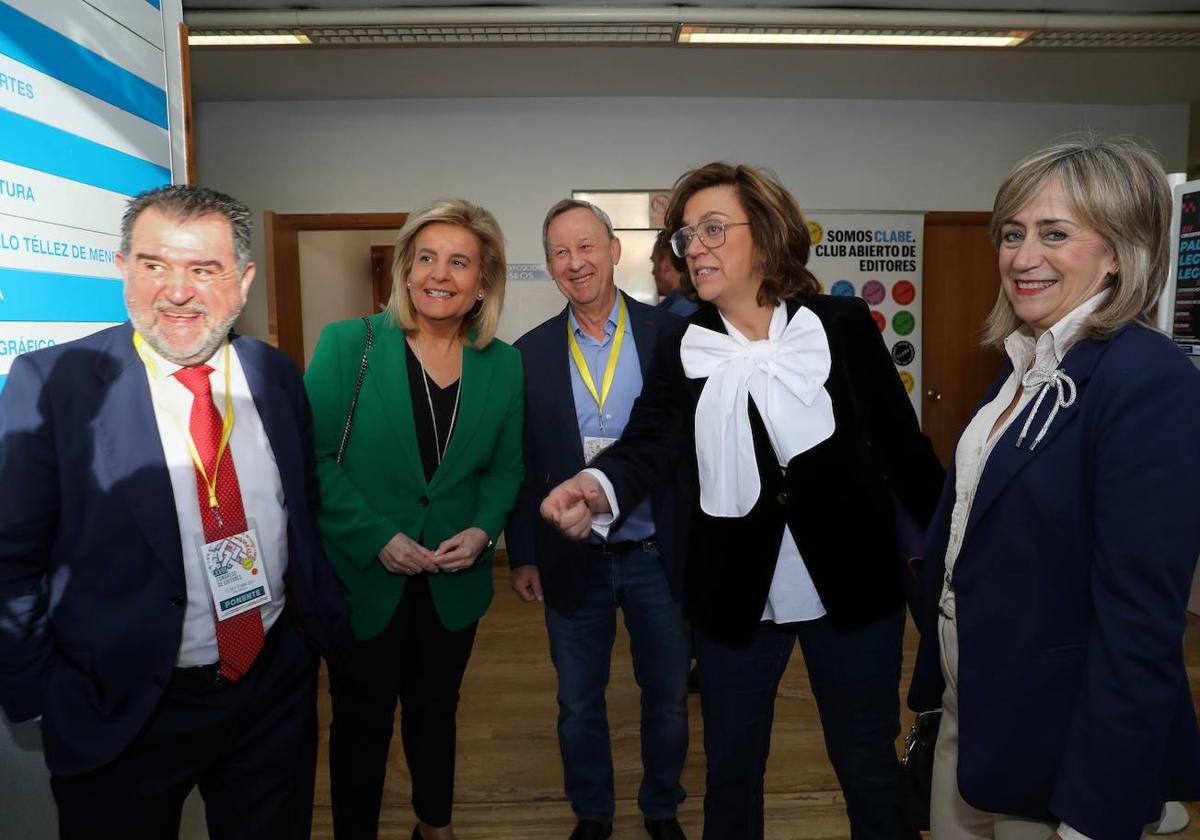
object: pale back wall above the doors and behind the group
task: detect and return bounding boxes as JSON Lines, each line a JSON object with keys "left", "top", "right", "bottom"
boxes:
{"left": 196, "top": 97, "right": 1188, "bottom": 340}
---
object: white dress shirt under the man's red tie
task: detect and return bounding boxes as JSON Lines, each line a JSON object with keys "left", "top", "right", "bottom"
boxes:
{"left": 142, "top": 342, "right": 288, "bottom": 667}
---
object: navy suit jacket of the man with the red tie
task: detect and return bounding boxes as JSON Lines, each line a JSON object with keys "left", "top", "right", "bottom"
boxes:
{"left": 0, "top": 322, "right": 348, "bottom": 774}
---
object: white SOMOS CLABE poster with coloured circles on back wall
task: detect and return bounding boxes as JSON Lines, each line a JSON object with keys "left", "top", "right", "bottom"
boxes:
{"left": 805, "top": 210, "right": 925, "bottom": 420}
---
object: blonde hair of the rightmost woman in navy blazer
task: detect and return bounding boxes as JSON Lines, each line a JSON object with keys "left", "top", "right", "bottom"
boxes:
{"left": 983, "top": 136, "right": 1171, "bottom": 348}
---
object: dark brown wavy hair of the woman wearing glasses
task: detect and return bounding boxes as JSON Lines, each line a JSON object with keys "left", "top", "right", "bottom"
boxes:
{"left": 664, "top": 161, "right": 821, "bottom": 306}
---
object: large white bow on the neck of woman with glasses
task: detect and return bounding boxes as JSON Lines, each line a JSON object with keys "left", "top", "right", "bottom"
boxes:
{"left": 679, "top": 304, "right": 834, "bottom": 516}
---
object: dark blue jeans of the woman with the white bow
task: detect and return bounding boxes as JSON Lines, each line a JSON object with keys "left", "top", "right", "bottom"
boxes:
{"left": 696, "top": 610, "right": 918, "bottom": 840}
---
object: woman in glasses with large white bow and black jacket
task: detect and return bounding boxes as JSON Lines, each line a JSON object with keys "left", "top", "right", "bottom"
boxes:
{"left": 542, "top": 163, "right": 943, "bottom": 840}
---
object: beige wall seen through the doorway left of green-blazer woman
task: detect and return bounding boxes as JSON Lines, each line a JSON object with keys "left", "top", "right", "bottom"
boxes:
{"left": 297, "top": 230, "right": 396, "bottom": 366}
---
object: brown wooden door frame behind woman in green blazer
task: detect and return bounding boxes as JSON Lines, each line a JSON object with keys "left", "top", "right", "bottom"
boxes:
{"left": 263, "top": 210, "right": 408, "bottom": 371}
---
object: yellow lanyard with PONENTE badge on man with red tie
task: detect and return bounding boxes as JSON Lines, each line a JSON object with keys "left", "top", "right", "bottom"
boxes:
{"left": 133, "top": 332, "right": 271, "bottom": 622}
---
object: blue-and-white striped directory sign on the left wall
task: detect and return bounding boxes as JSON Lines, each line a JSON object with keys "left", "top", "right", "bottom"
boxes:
{"left": 0, "top": 0, "right": 184, "bottom": 388}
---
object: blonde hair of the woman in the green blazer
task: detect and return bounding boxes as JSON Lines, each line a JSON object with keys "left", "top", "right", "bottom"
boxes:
{"left": 386, "top": 198, "right": 508, "bottom": 350}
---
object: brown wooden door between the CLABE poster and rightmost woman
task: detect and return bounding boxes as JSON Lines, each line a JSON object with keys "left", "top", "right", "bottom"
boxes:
{"left": 922, "top": 212, "right": 1004, "bottom": 466}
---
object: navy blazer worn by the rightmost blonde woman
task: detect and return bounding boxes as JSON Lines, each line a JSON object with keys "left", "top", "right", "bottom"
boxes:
{"left": 908, "top": 325, "right": 1200, "bottom": 840}
